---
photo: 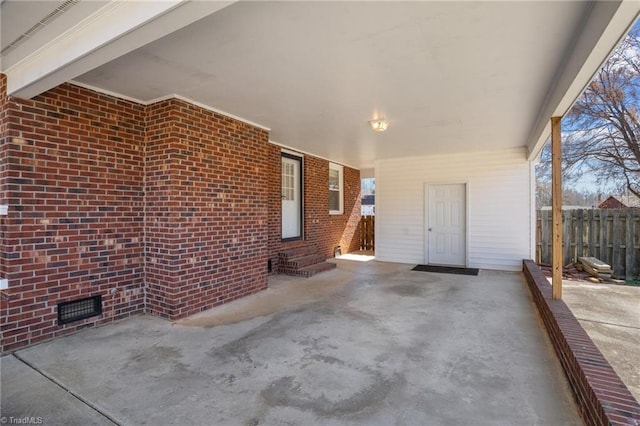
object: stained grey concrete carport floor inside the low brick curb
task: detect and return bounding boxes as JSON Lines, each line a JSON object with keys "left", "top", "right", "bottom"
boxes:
{"left": 1, "top": 259, "right": 582, "bottom": 425}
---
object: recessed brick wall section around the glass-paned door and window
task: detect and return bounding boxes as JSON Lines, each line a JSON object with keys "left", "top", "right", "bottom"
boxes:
{"left": 269, "top": 145, "right": 361, "bottom": 273}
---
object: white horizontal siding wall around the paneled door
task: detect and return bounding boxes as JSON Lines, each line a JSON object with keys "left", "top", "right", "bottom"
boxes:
{"left": 376, "top": 149, "right": 534, "bottom": 271}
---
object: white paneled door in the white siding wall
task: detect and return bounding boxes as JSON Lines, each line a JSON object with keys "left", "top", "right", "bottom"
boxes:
{"left": 425, "top": 184, "right": 467, "bottom": 266}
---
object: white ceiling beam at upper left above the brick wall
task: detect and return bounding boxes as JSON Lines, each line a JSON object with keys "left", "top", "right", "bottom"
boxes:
{"left": 3, "top": 0, "right": 234, "bottom": 98}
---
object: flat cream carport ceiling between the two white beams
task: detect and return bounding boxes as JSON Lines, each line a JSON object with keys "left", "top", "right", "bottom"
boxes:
{"left": 3, "top": 1, "right": 636, "bottom": 168}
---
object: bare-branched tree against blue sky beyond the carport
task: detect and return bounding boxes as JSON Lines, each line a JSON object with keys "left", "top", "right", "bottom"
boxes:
{"left": 556, "top": 21, "right": 640, "bottom": 197}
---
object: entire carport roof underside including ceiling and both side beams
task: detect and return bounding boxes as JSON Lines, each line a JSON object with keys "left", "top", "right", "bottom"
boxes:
{"left": 0, "top": 0, "right": 640, "bottom": 168}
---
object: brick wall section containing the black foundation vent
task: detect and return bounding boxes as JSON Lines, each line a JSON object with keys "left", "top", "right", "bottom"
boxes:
{"left": 1, "top": 84, "right": 144, "bottom": 351}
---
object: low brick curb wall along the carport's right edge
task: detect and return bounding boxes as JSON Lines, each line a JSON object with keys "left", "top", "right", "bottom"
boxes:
{"left": 523, "top": 260, "right": 640, "bottom": 426}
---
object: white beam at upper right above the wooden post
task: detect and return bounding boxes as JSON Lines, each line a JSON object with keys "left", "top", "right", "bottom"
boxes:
{"left": 527, "top": 0, "right": 640, "bottom": 160}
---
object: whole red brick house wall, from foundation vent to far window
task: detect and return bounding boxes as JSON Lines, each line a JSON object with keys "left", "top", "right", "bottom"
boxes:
{"left": 0, "top": 74, "right": 360, "bottom": 352}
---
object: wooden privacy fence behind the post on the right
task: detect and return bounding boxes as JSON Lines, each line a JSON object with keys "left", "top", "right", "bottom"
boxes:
{"left": 536, "top": 208, "right": 640, "bottom": 279}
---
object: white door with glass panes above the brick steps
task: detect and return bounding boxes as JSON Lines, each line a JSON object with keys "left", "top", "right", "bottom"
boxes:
{"left": 281, "top": 153, "right": 302, "bottom": 240}
